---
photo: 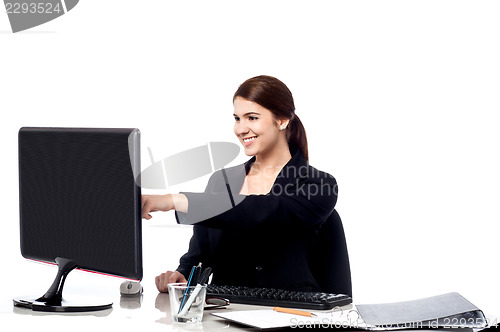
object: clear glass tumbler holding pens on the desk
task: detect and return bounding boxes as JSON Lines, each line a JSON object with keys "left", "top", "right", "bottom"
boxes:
{"left": 168, "top": 283, "right": 207, "bottom": 323}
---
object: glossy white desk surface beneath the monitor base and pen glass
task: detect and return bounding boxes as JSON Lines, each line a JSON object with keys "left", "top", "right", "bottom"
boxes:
{"left": 0, "top": 292, "right": 492, "bottom": 332}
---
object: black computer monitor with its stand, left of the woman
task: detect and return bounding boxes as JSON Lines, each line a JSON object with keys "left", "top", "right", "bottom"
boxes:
{"left": 14, "top": 128, "right": 142, "bottom": 311}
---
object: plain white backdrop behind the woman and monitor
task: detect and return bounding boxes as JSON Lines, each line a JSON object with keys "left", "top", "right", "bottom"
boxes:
{"left": 0, "top": 0, "right": 500, "bottom": 326}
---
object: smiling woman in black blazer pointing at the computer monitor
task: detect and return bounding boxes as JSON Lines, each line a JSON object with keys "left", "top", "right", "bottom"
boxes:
{"left": 143, "top": 76, "right": 337, "bottom": 292}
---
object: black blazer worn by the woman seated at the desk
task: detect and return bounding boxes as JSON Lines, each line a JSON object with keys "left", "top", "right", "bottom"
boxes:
{"left": 176, "top": 151, "right": 337, "bottom": 291}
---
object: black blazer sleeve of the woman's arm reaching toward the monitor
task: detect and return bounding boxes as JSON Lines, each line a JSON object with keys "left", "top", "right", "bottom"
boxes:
{"left": 176, "top": 172, "right": 337, "bottom": 230}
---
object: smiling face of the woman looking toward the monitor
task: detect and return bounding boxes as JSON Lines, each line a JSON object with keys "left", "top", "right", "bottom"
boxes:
{"left": 234, "top": 97, "right": 288, "bottom": 156}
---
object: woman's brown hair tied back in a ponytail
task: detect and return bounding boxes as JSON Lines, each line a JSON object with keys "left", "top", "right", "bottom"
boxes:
{"left": 233, "top": 75, "right": 309, "bottom": 160}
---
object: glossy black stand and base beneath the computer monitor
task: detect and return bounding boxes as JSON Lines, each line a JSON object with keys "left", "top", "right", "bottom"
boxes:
{"left": 14, "top": 257, "right": 113, "bottom": 312}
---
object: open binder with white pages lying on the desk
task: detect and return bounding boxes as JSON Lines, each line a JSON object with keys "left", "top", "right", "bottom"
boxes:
{"left": 212, "top": 293, "right": 488, "bottom": 331}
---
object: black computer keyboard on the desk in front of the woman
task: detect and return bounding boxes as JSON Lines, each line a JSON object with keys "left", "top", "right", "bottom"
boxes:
{"left": 207, "top": 284, "right": 352, "bottom": 310}
